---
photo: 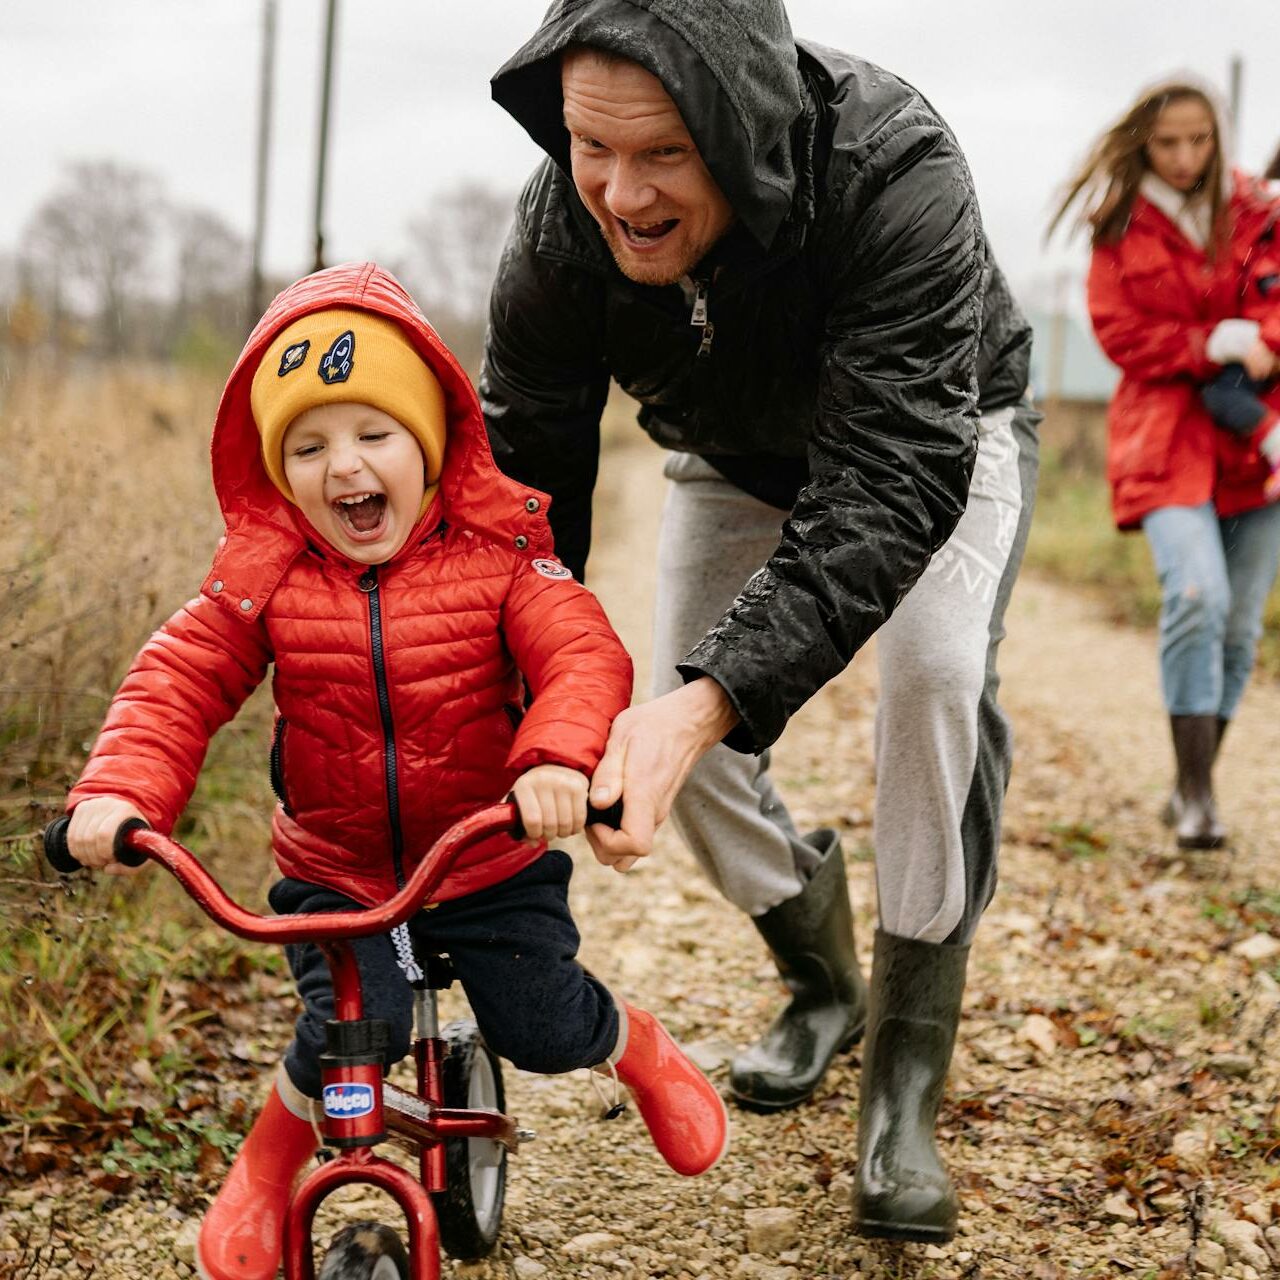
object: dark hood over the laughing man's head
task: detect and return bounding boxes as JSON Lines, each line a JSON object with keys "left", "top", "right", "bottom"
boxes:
{"left": 492, "top": 0, "right": 803, "bottom": 248}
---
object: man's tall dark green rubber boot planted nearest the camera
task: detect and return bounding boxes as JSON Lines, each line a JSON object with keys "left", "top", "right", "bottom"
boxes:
{"left": 854, "top": 929, "right": 969, "bottom": 1243}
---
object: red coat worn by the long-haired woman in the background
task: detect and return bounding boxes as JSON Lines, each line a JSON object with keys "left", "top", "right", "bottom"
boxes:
{"left": 1088, "top": 174, "right": 1280, "bottom": 529}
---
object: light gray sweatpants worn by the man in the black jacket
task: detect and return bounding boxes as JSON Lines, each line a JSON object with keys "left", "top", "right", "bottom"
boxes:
{"left": 654, "top": 404, "right": 1038, "bottom": 943}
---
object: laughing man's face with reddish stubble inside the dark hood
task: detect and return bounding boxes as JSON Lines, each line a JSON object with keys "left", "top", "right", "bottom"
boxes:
{"left": 561, "top": 50, "right": 733, "bottom": 284}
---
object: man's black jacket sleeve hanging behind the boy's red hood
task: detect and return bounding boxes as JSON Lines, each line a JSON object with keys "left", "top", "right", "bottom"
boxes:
{"left": 480, "top": 183, "right": 609, "bottom": 581}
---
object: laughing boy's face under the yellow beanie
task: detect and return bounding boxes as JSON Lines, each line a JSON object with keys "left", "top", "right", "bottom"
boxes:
{"left": 283, "top": 404, "right": 426, "bottom": 564}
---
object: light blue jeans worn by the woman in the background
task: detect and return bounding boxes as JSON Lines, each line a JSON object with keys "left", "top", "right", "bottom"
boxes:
{"left": 1142, "top": 503, "right": 1280, "bottom": 719}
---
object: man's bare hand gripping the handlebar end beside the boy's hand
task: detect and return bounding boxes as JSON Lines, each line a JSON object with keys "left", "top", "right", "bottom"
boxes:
{"left": 586, "top": 676, "right": 740, "bottom": 872}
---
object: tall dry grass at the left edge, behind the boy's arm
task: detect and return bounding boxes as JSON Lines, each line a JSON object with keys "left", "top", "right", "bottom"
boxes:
{"left": 0, "top": 365, "right": 281, "bottom": 1117}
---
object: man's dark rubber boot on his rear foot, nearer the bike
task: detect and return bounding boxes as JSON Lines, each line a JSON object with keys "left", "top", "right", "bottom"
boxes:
{"left": 728, "top": 829, "right": 867, "bottom": 1111}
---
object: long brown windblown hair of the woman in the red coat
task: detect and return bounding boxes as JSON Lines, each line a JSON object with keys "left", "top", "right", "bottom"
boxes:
{"left": 1046, "top": 81, "right": 1226, "bottom": 257}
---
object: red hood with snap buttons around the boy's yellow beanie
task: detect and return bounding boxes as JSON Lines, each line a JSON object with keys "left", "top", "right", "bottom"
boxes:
{"left": 205, "top": 262, "right": 553, "bottom": 618}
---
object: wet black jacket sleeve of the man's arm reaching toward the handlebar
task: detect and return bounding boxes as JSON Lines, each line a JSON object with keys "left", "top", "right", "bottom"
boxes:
{"left": 681, "top": 119, "right": 986, "bottom": 751}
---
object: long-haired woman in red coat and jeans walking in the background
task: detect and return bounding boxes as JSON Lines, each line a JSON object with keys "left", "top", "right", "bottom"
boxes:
{"left": 1050, "top": 83, "right": 1280, "bottom": 849}
